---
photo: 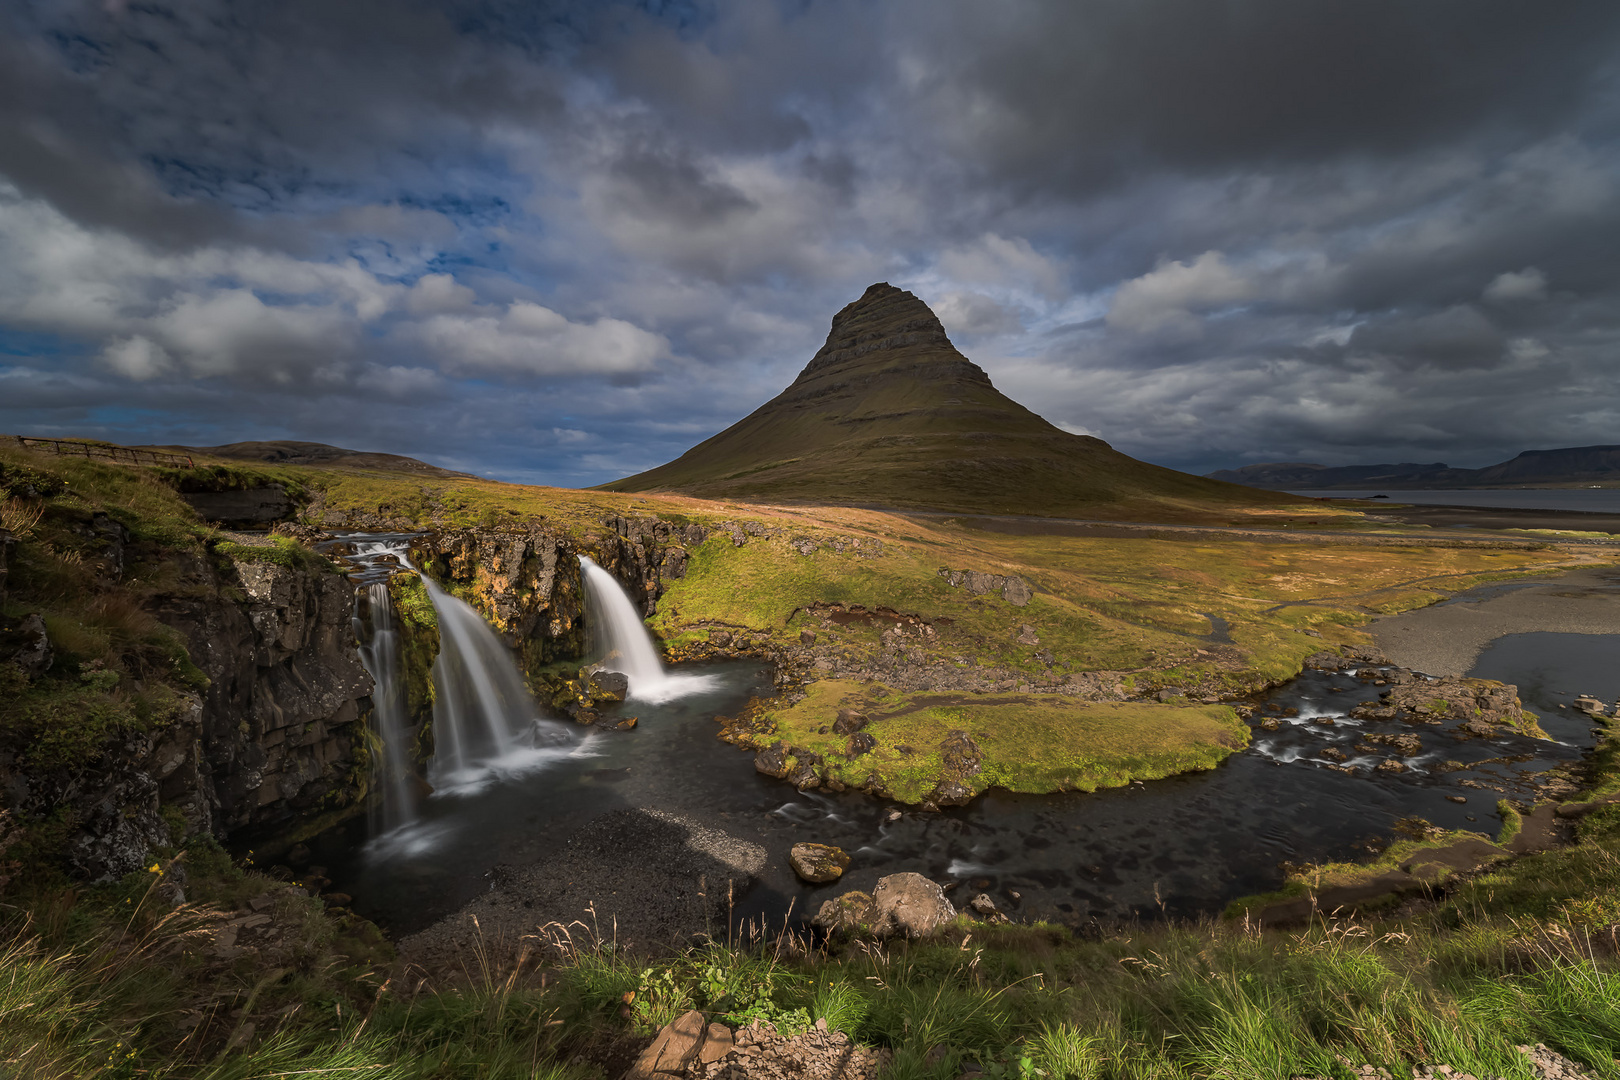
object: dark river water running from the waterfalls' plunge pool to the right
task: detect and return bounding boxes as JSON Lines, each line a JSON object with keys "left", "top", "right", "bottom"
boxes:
{"left": 311, "top": 635, "right": 1620, "bottom": 934}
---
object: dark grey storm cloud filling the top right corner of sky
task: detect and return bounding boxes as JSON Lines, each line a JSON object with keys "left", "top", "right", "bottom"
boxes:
{"left": 917, "top": 0, "right": 1620, "bottom": 186}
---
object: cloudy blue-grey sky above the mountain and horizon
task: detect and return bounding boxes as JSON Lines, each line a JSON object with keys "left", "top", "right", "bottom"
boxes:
{"left": 0, "top": 0, "right": 1620, "bottom": 486}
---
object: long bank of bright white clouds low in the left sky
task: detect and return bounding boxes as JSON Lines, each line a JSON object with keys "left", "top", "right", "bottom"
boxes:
{"left": 0, "top": 188, "right": 671, "bottom": 386}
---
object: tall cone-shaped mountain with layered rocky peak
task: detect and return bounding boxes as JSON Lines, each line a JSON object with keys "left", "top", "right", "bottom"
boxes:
{"left": 603, "top": 283, "right": 1290, "bottom": 520}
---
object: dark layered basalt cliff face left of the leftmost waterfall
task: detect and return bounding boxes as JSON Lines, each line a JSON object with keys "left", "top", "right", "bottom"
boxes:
{"left": 10, "top": 554, "right": 373, "bottom": 881}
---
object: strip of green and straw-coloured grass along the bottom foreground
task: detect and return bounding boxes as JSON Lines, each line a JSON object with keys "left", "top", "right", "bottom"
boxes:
{"left": 9, "top": 814, "right": 1620, "bottom": 1080}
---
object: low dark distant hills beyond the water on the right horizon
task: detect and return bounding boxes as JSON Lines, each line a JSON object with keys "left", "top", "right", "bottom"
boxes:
{"left": 1209, "top": 447, "right": 1620, "bottom": 491}
